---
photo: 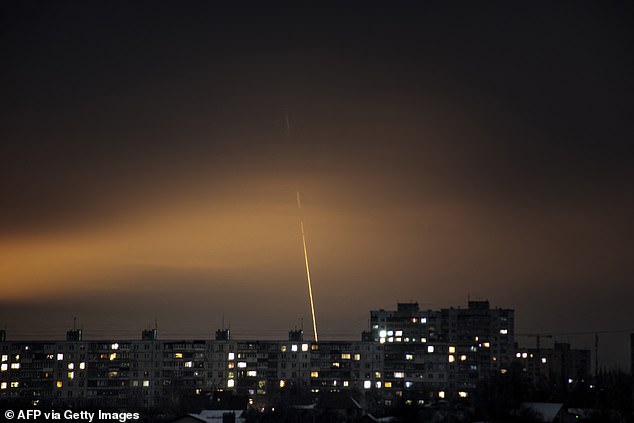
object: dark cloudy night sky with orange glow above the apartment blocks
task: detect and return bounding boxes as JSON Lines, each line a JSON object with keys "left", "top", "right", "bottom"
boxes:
{"left": 0, "top": 1, "right": 634, "bottom": 368}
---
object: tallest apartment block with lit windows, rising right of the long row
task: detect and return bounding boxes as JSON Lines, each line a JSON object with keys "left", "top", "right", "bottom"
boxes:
{"left": 370, "top": 301, "right": 514, "bottom": 403}
